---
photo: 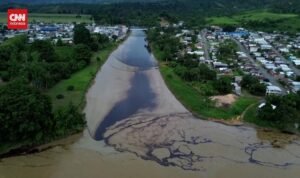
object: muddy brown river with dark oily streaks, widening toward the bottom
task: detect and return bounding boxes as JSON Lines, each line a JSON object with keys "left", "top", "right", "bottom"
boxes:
{"left": 0, "top": 30, "right": 300, "bottom": 178}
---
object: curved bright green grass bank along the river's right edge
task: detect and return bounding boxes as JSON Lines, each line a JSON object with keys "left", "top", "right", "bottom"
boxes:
{"left": 160, "top": 65, "right": 257, "bottom": 119}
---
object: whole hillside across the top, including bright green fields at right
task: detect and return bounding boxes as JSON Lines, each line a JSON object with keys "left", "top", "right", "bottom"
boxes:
{"left": 0, "top": 0, "right": 300, "bottom": 32}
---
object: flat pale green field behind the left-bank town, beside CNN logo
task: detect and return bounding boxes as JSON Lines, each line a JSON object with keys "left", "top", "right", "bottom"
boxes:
{"left": 0, "top": 13, "right": 93, "bottom": 23}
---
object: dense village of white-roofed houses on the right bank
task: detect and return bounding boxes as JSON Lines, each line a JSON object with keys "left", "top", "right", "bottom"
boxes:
{"left": 175, "top": 25, "right": 300, "bottom": 95}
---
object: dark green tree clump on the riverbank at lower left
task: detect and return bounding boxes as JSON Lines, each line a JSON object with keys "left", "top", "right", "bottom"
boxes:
{"left": 0, "top": 79, "right": 85, "bottom": 154}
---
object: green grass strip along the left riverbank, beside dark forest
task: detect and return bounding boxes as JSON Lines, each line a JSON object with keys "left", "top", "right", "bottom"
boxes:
{"left": 47, "top": 44, "right": 117, "bottom": 110}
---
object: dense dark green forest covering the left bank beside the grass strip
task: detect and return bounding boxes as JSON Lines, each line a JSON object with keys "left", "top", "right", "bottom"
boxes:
{"left": 0, "top": 24, "right": 110, "bottom": 154}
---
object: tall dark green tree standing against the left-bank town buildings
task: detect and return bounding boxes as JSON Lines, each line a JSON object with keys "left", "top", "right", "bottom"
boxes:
{"left": 73, "top": 24, "right": 91, "bottom": 46}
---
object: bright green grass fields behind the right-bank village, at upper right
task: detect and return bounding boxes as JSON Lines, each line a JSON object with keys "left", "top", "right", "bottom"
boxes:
{"left": 206, "top": 10, "right": 300, "bottom": 32}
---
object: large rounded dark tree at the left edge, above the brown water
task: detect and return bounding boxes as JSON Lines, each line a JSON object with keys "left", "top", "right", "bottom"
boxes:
{"left": 0, "top": 80, "right": 54, "bottom": 143}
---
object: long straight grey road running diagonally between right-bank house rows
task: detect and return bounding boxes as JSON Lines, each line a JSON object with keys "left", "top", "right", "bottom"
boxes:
{"left": 232, "top": 38, "right": 287, "bottom": 93}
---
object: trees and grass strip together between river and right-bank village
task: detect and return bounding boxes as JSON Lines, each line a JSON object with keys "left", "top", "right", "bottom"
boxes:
{"left": 148, "top": 29, "right": 257, "bottom": 119}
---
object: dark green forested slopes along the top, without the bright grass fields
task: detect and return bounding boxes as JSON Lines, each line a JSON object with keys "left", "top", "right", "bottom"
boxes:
{"left": 0, "top": 0, "right": 300, "bottom": 26}
